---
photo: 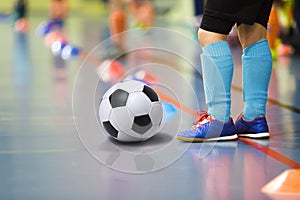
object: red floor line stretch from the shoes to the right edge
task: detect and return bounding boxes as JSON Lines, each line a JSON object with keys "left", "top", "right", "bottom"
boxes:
{"left": 239, "top": 138, "right": 300, "bottom": 169}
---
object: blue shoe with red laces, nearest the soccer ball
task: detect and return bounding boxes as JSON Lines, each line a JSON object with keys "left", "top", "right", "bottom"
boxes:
{"left": 176, "top": 111, "right": 238, "bottom": 142}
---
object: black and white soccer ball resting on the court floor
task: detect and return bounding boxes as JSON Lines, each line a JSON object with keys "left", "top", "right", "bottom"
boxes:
{"left": 99, "top": 80, "right": 163, "bottom": 142}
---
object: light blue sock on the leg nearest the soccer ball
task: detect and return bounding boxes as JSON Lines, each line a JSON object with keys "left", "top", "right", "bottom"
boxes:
{"left": 201, "top": 41, "right": 233, "bottom": 122}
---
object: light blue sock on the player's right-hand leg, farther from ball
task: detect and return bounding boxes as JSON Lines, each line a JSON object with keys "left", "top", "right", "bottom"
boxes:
{"left": 242, "top": 40, "right": 272, "bottom": 120}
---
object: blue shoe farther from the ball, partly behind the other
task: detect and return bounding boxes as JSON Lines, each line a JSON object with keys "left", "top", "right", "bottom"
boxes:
{"left": 235, "top": 114, "right": 270, "bottom": 138}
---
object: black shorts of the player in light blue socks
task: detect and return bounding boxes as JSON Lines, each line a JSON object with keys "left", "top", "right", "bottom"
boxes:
{"left": 200, "top": 0, "right": 273, "bottom": 35}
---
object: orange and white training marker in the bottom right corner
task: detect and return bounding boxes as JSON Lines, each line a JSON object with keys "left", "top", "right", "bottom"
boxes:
{"left": 262, "top": 169, "right": 300, "bottom": 200}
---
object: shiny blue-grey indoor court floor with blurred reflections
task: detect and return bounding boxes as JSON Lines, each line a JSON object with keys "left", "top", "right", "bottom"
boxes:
{"left": 0, "top": 3, "right": 300, "bottom": 200}
